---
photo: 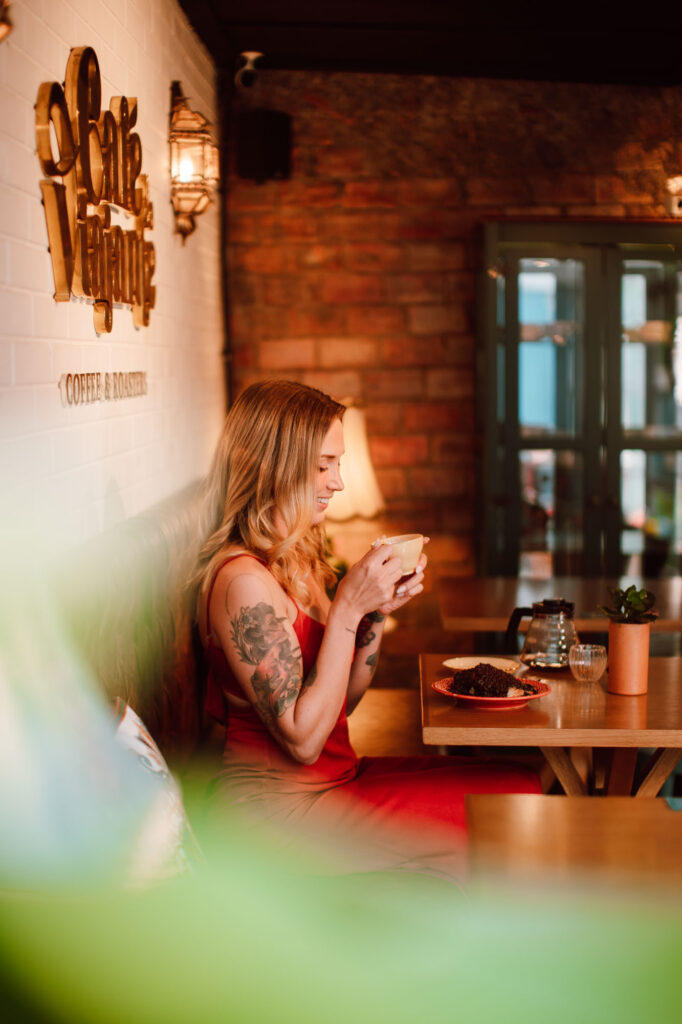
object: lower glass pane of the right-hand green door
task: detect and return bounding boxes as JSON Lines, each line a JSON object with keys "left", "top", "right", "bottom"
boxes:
{"left": 621, "top": 449, "right": 682, "bottom": 579}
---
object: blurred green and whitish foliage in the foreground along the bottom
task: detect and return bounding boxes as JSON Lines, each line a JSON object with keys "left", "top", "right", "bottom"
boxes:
{"left": 0, "top": 536, "right": 682, "bottom": 1024}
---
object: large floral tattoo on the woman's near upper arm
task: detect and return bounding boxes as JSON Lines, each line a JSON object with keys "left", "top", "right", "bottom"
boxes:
{"left": 229, "top": 601, "right": 303, "bottom": 725}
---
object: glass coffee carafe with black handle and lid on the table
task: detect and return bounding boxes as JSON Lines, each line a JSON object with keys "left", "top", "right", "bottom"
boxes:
{"left": 507, "top": 597, "right": 579, "bottom": 669}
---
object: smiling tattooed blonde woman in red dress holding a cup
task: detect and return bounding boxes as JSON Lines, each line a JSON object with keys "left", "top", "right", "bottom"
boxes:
{"left": 189, "top": 380, "right": 540, "bottom": 880}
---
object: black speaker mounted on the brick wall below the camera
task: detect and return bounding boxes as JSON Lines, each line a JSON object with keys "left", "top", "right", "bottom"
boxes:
{"left": 237, "top": 106, "right": 291, "bottom": 182}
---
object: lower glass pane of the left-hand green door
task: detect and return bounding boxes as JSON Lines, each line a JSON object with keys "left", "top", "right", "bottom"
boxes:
{"left": 519, "top": 450, "right": 583, "bottom": 578}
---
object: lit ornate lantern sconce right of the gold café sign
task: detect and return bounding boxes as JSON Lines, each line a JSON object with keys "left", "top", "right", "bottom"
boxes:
{"left": 169, "top": 82, "right": 218, "bottom": 243}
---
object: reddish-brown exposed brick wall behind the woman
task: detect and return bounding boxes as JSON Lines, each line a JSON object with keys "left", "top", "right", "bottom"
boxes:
{"left": 228, "top": 72, "right": 682, "bottom": 539}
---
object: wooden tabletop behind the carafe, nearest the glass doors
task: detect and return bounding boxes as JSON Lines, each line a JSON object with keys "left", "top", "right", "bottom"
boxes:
{"left": 437, "top": 571, "right": 682, "bottom": 634}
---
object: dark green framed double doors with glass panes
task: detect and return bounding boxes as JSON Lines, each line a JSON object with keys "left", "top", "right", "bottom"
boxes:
{"left": 478, "top": 224, "right": 682, "bottom": 575}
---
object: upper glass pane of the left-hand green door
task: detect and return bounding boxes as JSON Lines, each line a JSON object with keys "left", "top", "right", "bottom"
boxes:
{"left": 518, "top": 258, "right": 585, "bottom": 437}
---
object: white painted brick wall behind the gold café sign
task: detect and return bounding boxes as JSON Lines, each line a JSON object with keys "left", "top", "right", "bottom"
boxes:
{"left": 0, "top": 0, "right": 225, "bottom": 550}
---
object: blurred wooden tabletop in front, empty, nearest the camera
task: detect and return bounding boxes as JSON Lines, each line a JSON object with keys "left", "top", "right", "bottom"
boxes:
{"left": 467, "top": 794, "right": 682, "bottom": 888}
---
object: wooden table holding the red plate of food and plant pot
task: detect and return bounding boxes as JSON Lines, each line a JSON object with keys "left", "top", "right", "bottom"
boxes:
{"left": 419, "top": 654, "right": 682, "bottom": 797}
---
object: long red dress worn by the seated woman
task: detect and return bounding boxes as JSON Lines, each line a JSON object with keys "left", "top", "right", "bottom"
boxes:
{"left": 206, "top": 556, "right": 540, "bottom": 879}
